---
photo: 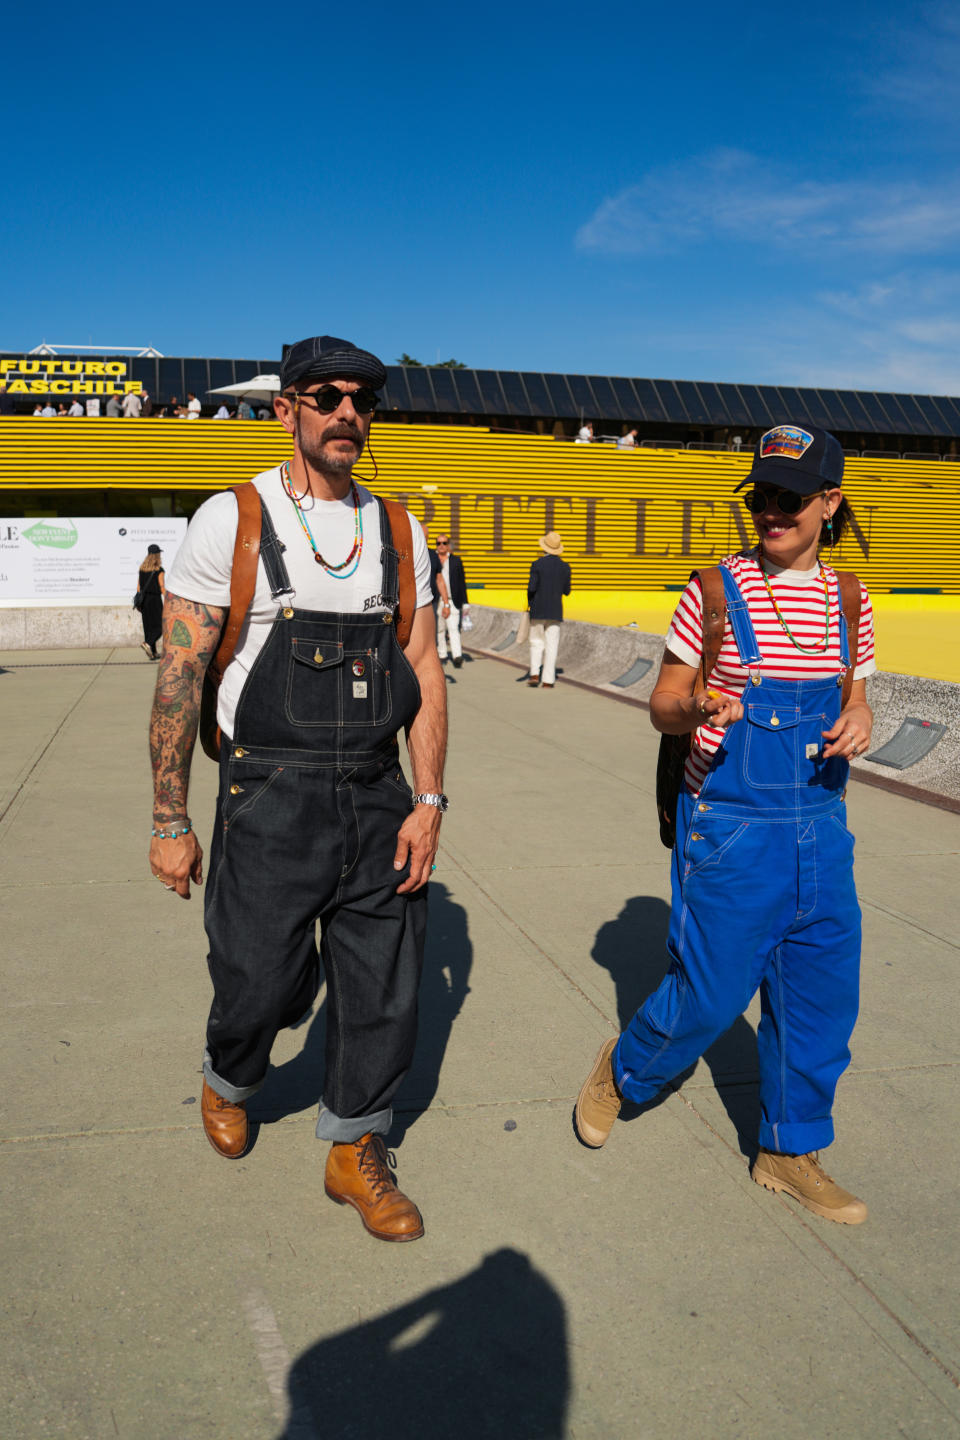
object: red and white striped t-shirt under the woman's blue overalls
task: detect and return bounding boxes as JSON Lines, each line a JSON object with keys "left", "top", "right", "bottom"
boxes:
{"left": 665, "top": 550, "right": 877, "bottom": 795}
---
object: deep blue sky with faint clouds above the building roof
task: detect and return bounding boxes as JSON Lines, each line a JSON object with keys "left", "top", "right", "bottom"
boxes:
{"left": 0, "top": 0, "right": 960, "bottom": 395}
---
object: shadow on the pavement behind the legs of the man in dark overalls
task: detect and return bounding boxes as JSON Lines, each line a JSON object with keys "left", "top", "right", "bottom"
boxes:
{"left": 246, "top": 880, "right": 474, "bottom": 1146}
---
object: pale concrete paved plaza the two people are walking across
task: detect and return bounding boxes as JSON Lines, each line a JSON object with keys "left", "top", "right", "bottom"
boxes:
{"left": 0, "top": 649, "right": 960, "bottom": 1440}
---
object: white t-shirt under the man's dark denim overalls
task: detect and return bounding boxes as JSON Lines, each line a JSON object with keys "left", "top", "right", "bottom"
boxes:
{"left": 167, "top": 465, "right": 433, "bottom": 736}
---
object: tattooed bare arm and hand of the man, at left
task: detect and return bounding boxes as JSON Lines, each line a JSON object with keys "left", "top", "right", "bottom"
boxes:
{"left": 150, "top": 592, "right": 226, "bottom": 900}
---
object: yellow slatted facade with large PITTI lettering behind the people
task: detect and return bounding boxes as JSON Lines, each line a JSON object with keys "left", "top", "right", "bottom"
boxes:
{"left": 0, "top": 418, "right": 960, "bottom": 595}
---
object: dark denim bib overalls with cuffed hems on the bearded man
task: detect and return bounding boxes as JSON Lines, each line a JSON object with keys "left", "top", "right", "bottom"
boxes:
{"left": 204, "top": 498, "right": 426, "bottom": 1140}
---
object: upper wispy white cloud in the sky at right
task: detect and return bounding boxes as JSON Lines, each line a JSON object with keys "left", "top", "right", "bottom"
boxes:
{"left": 576, "top": 150, "right": 960, "bottom": 255}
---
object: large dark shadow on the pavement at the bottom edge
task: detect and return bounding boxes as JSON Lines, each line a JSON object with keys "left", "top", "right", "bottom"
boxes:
{"left": 278, "top": 1248, "right": 570, "bottom": 1440}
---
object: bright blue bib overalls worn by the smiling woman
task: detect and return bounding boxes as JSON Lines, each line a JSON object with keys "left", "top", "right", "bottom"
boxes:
{"left": 613, "top": 566, "right": 861, "bottom": 1155}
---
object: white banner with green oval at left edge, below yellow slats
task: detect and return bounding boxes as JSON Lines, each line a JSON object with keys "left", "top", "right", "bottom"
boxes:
{"left": 0, "top": 516, "right": 187, "bottom": 606}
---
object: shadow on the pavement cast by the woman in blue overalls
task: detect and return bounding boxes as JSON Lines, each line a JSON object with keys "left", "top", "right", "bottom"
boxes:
{"left": 590, "top": 896, "right": 760, "bottom": 1156}
